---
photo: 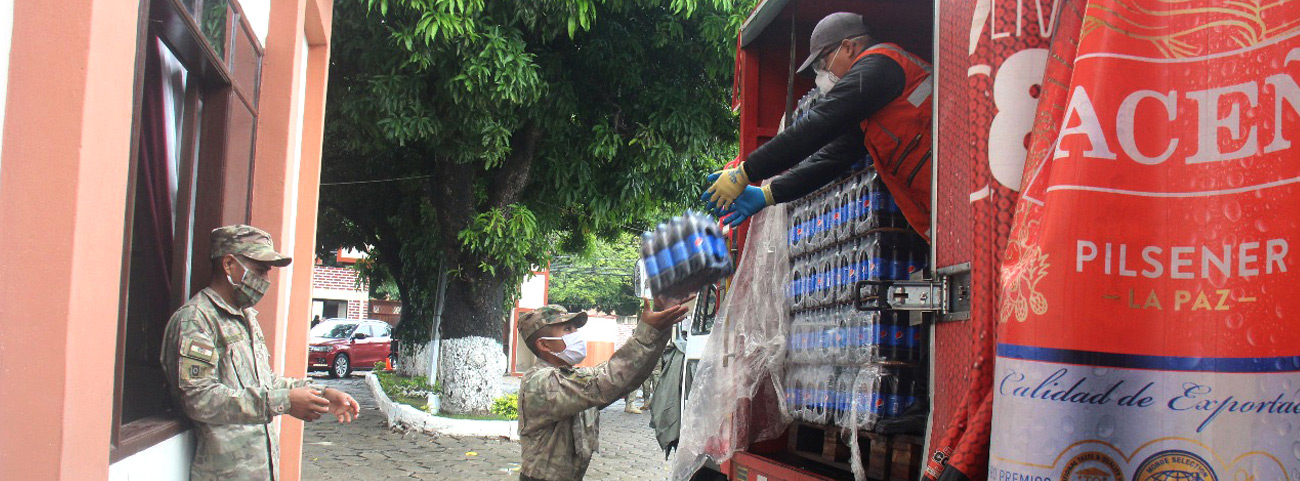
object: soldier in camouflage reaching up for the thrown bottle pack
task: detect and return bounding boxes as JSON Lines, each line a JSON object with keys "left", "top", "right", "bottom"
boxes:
{"left": 519, "top": 302, "right": 686, "bottom": 481}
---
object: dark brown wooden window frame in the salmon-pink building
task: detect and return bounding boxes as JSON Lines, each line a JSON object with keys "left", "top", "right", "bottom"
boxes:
{"left": 109, "top": 0, "right": 265, "bottom": 463}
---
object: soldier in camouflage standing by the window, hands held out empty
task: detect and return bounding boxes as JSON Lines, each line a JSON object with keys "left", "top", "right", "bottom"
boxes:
{"left": 161, "top": 225, "right": 360, "bottom": 481}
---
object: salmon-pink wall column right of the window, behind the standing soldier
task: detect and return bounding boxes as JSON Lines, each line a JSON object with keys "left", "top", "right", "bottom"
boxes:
{"left": 252, "top": 0, "right": 333, "bottom": 481}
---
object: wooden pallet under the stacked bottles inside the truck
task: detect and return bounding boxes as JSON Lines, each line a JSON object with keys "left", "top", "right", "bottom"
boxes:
{"left": 787, "top": 421, "right": 924, "bottom": 481}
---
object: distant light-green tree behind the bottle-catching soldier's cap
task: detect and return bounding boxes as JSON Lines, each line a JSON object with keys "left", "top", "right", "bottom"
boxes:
{"left": 549, "top": 234, "right": 641, "bottom": 316}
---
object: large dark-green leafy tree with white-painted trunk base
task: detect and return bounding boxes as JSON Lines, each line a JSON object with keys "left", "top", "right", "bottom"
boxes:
{"left": 319, "top": 0, "right": 749, "bottom": 412}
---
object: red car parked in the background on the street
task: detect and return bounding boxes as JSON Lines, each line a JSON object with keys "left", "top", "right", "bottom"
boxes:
{"left": 307, "top": 319, "right": 393, "bottom": 377}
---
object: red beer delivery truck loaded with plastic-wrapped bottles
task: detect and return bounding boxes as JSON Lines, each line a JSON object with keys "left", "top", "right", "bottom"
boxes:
{"left": 673, "top": 0, "right": 1300, "bottom": 481}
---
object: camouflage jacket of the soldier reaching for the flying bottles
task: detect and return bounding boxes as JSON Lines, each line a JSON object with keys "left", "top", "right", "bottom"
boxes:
{"left": 519, "top": 324, "right": 670, "bottom": 481}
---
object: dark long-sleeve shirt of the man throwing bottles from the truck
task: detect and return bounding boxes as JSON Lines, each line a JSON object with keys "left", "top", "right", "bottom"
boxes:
{"left": 742, "top": 49, "right": 907, "bottom": 203}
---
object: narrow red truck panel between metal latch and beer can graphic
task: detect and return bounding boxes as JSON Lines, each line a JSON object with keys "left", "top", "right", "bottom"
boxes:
{"left": 927, "top": 0, "right": 1063, "bottom": 480}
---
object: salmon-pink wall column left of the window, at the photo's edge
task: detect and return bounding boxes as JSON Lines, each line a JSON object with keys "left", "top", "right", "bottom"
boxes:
{"left": 0, "top": 0, "right": 139, "bottom": 480}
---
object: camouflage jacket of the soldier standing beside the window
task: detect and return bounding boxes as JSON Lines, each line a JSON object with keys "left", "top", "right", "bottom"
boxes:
{"left": 163, "top": 287, "right": 314, "bottom": 481}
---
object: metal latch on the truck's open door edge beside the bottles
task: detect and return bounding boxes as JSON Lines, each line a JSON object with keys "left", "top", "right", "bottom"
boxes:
{"left": 853, "top": 263, "right": 971, "bottom": 321}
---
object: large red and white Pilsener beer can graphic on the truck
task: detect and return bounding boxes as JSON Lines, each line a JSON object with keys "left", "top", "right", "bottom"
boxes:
{"left": 988, "top": 0, "right": 1300, "bottom": 481}
